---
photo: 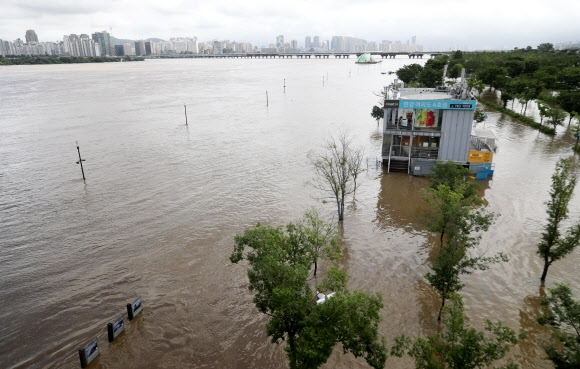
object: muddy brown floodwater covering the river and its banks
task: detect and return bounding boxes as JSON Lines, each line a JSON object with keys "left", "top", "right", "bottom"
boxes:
{"left": 0, "top": 58, "right": 580, "bottom": 368}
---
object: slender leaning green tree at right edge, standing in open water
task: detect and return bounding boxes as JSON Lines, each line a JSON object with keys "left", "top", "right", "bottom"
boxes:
{"left": 537, "top": 159, "right": 580, "bottom": 283}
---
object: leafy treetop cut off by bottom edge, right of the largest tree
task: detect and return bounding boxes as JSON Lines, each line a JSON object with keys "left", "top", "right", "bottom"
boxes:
{"left": 391, "top": 294, "right": 518, "bottom": 369}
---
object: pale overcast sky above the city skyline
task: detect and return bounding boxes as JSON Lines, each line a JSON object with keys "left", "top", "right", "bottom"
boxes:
{"left": 0, "top": 0, "right": 580, "bottom": 51}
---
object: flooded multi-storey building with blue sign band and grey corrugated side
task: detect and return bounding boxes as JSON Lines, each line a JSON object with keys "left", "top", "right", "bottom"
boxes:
{"left": 382, "top": 78, "right": 493, "bottom": 176}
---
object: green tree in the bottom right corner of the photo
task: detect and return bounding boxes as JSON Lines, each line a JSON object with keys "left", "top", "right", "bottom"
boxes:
{"left": 538, "top": 283, "right": 580, "bottom": 369}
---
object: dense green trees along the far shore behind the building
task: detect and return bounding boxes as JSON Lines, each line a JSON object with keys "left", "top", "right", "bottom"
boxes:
{"left": 396, "top": 43, "right": 580, "bottom": 134}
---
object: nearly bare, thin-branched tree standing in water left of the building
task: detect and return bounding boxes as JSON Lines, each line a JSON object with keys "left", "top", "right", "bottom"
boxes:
{"left": 308, "top": 132, "right": 364, "bottom": 221}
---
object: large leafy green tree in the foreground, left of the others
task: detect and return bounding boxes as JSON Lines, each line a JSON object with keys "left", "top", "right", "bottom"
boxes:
{"left": 230, "top": 218, "right": 387, "bottom": 369}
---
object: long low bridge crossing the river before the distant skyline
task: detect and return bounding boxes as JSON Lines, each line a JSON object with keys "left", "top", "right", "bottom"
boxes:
{"left": 147, "top": 51, "right": 449, "bottom": 59}
